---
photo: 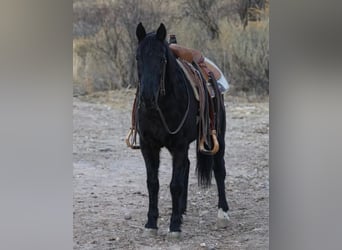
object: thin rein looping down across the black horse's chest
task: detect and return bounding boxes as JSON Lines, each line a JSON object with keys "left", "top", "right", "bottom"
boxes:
{"left": 156, "top": 59, "right": 190, "bottom": 135}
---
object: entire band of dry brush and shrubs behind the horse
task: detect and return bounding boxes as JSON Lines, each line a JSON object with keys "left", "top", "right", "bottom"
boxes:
{"left": 73, "top": 0, "right": 269, "bottom": 96}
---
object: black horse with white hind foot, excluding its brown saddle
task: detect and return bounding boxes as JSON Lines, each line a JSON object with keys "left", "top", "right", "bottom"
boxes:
{"left": 136, "top": 23, "right": 229, "bottom": 236}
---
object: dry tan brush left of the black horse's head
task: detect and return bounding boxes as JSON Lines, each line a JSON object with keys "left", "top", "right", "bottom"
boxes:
{"left": 73, "top": 0, "right": 168, "bottom": 93}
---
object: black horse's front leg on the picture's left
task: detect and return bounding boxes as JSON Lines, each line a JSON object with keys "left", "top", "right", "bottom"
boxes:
{"left": 140, "top": 142, "right": 160, "bottom": 234}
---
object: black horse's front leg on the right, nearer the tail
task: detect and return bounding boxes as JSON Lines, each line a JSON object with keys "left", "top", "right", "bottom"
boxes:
{"left": 170, "top": 147, "right": 189, "bottom": 237}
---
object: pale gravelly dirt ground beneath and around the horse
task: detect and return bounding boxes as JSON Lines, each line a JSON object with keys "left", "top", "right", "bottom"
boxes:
{"left": 73, "top": 90, "right": 269, "bottom": 250}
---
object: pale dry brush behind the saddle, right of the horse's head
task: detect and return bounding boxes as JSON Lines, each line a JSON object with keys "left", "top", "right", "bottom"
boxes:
{"left": 172, "top": 17, "right": 269, "bottom": 96}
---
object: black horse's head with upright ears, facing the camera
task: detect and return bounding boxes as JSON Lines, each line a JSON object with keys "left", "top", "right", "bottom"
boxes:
{"left": 136, "top": 23, "right": 168, "bottom": 108}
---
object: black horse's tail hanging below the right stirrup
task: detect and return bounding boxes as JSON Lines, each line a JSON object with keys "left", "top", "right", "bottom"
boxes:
{"left": 196, "top": 142, "right": 214, "bottom": 188}
